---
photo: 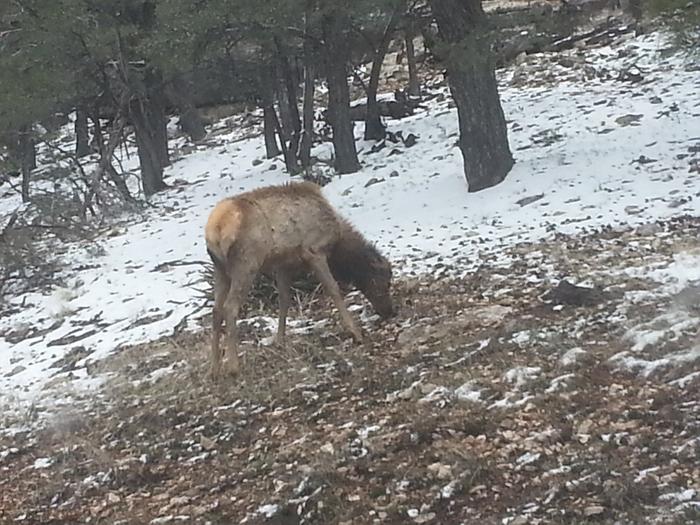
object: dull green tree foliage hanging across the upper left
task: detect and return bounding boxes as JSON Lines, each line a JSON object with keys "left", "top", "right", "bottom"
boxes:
{"left": 0, "top": 0, "right": 408, "bottom": 132}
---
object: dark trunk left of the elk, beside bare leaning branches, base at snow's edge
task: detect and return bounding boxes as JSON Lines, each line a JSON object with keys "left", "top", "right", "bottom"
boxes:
{"left": 130, "top": 69, "right": 169, "bottom": 197}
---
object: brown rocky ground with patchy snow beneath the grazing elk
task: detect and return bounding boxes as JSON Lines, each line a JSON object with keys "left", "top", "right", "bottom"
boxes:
{"left": 0, "top": 218, "right": 700, "bottom": 525}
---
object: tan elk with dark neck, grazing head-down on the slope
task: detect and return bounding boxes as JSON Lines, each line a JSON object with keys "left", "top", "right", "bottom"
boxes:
{"left": 205, "top": 182, "right": 394, "bottom": 378}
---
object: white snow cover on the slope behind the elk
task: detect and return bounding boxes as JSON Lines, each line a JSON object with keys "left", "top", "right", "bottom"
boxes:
{"left": 0, "top": 34, "right": 700, "bottom": 426}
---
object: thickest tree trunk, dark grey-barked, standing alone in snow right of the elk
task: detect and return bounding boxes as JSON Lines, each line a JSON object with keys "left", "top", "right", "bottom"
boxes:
{"left": 430, "top": 0, "right": 514, "bottom": 192}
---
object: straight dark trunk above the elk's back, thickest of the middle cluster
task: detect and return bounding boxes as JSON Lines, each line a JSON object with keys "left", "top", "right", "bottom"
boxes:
{"left": 323, "top": 12, "right": 360, "bottom": 173}
